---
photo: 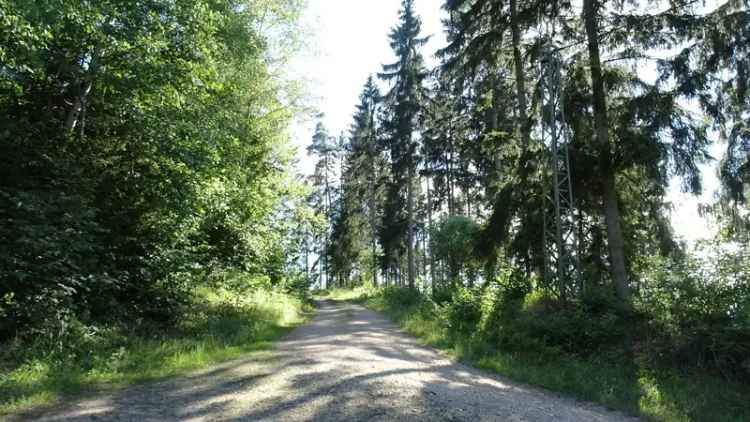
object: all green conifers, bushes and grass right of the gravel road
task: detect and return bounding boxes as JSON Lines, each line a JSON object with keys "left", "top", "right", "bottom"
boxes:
{"left": 312, "top": 0, "right": 750, "bottom": 420}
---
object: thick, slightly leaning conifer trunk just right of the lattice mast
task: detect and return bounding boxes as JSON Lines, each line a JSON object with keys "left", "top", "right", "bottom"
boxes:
{"left": 583, "top": 0, "right": 630, "bottom": 305}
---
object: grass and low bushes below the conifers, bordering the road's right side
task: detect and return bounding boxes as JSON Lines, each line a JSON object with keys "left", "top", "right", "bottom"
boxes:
{"left": 328, "top": 289, "right": 750, "bottom": 422}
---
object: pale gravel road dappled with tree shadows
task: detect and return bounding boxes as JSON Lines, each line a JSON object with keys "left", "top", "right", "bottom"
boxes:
{"left": 20, "top": 301, "right": 635, "bottom": 422}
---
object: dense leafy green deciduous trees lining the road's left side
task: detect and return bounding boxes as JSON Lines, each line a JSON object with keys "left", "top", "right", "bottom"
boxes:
{"left": 0, "top": 0, "right": 306, "bottom": 342}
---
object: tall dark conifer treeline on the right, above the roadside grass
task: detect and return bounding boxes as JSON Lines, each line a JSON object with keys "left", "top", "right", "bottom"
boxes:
{"left": 301, "top": 0, "right": 750, "bottom": 380}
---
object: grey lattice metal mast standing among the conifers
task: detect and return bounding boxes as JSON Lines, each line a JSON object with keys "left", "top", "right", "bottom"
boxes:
{"left": 540, "top": 42, "right": 582, "bottom": 300}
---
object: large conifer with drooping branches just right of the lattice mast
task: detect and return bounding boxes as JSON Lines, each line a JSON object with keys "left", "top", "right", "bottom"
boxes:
{"left": 565, "top": 0, "right": 709, "bottom": 306}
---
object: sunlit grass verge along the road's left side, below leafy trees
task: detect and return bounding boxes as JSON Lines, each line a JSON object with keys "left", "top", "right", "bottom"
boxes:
{"left": 0, "top": 290, "right": 307, "bottom": 416}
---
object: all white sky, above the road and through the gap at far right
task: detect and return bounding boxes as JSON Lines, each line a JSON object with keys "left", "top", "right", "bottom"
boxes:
{"left": 290, "top": 0, "right": 722, "bottom": 243}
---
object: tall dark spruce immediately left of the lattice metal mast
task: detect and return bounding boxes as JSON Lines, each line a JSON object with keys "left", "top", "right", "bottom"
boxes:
{"left": 439, "top": 0, "right": 556, "bottom": 274}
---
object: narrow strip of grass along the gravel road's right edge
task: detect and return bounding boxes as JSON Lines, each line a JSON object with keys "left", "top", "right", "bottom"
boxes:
{"left": 327, "top": 289, "right": 750, "bottom": 422}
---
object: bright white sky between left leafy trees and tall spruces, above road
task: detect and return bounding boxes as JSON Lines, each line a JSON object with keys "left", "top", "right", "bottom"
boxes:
{"left": 293, "top": 0, "right": 445, "bottom": 164}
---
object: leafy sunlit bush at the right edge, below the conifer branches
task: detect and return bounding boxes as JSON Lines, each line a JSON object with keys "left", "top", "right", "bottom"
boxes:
{"left": 639, "top": 244, "right": 750, "bottom": 382}
